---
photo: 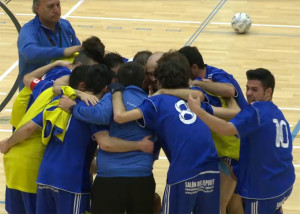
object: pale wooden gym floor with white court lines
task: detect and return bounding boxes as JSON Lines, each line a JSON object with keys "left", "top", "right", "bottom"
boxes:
{"left": 0, "top": 0, "right": 300, "bottom": 214}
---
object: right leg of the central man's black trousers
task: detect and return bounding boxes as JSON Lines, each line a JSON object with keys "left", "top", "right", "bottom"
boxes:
{"left": 126, "top": 175, "right": 155, "bottom": 214}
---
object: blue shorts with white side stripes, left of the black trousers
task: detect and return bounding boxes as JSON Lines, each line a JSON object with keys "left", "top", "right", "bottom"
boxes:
{"left": 36, "top": 184, "right": 90, "bottom": 214}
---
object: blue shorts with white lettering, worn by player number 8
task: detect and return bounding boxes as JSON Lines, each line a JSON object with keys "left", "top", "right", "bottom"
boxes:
{"left": 162, "top": 171, "right": 220, "bottom": 214}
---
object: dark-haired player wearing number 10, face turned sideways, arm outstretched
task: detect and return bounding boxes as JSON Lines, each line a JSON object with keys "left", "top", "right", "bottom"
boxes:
{"left": 188, "top": 68, "right": 295, "bottom": 214}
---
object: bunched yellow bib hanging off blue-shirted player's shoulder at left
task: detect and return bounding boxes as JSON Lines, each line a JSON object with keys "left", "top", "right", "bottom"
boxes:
{"left": 42, "top": 86, "right": 76, "bottom": 145}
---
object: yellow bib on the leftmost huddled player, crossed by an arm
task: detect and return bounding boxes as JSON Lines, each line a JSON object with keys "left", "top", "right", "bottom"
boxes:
{"left": 4, "top": 87, "right": 69, "bottom": 193}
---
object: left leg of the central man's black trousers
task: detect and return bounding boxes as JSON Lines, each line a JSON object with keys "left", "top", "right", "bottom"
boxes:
{"left": 91, "top": 176, "right": 126, "bottom": 213}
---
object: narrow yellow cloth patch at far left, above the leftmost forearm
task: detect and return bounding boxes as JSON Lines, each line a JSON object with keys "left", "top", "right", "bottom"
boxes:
{"left": 10, "top": 87, "right": 31, "bottom": 127}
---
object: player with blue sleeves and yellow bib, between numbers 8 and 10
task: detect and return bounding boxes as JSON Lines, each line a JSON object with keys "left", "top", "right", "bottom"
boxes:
{"left": 179, "top": 46, "right": 247, "bottom": 214}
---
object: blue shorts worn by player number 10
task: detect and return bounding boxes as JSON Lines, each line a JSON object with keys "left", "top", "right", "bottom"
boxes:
{"left": 243, "top": 187, "right": 293, "bottom": 214}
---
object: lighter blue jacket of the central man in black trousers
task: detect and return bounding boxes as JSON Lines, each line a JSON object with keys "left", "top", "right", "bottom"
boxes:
{"left": 73, "top": 86, "right": 153, "bottom": 177}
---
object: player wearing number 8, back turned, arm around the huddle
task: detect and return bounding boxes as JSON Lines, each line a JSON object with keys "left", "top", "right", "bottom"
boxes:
{"left": 113, "top": 52, "right": 220, "bottom": 214}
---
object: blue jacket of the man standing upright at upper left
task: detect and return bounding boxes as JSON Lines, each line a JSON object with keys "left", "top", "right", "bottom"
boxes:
{"left": 18, "top": 15, "right": 80, "bottom": 89}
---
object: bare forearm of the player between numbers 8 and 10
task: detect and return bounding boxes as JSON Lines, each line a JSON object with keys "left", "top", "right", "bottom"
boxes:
{"left": 190, "top": 80, "right": 235, "bottom": 97}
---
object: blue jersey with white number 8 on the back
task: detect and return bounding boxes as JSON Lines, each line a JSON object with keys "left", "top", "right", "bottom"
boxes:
{"left": 138, "top": 95, "right": 219, "bottom": 184}
